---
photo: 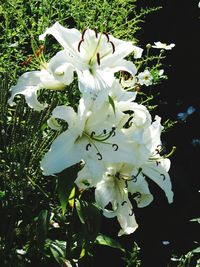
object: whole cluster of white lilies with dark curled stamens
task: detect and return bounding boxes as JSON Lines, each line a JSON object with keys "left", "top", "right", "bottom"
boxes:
{"left": 9, "top": 22, "right": 174, "bottom": 235}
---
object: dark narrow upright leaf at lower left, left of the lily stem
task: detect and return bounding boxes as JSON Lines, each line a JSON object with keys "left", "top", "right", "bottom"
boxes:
{"left": 36, "top": 210, "right": 50, "bottom": 250}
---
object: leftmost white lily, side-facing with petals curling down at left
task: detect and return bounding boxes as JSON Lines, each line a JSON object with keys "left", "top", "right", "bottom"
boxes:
{"left": 8, "top": 55, "right": 68, "bottom": 111}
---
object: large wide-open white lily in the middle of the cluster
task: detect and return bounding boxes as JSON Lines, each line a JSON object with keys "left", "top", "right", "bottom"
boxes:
{"left": 41, "top": 99, "right": 136, "bottom": 175}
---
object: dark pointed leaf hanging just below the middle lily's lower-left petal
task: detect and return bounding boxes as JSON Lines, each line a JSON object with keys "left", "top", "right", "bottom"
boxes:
{"left": 57, "top": 165, "right": 78, "bottom": 215}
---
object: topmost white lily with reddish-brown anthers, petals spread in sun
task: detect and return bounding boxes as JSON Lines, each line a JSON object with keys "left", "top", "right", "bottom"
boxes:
{"left": 39, "top": 22, "right": 139, "bottom": 93}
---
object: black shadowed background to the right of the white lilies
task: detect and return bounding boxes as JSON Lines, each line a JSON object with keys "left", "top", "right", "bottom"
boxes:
{"left": 95, "top": 0, "right": 200, "bottom": 267}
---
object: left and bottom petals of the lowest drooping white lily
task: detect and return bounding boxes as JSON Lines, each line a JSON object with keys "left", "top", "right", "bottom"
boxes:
{"left": 95, "top": 164, "right": 138, "bottom": 236}
